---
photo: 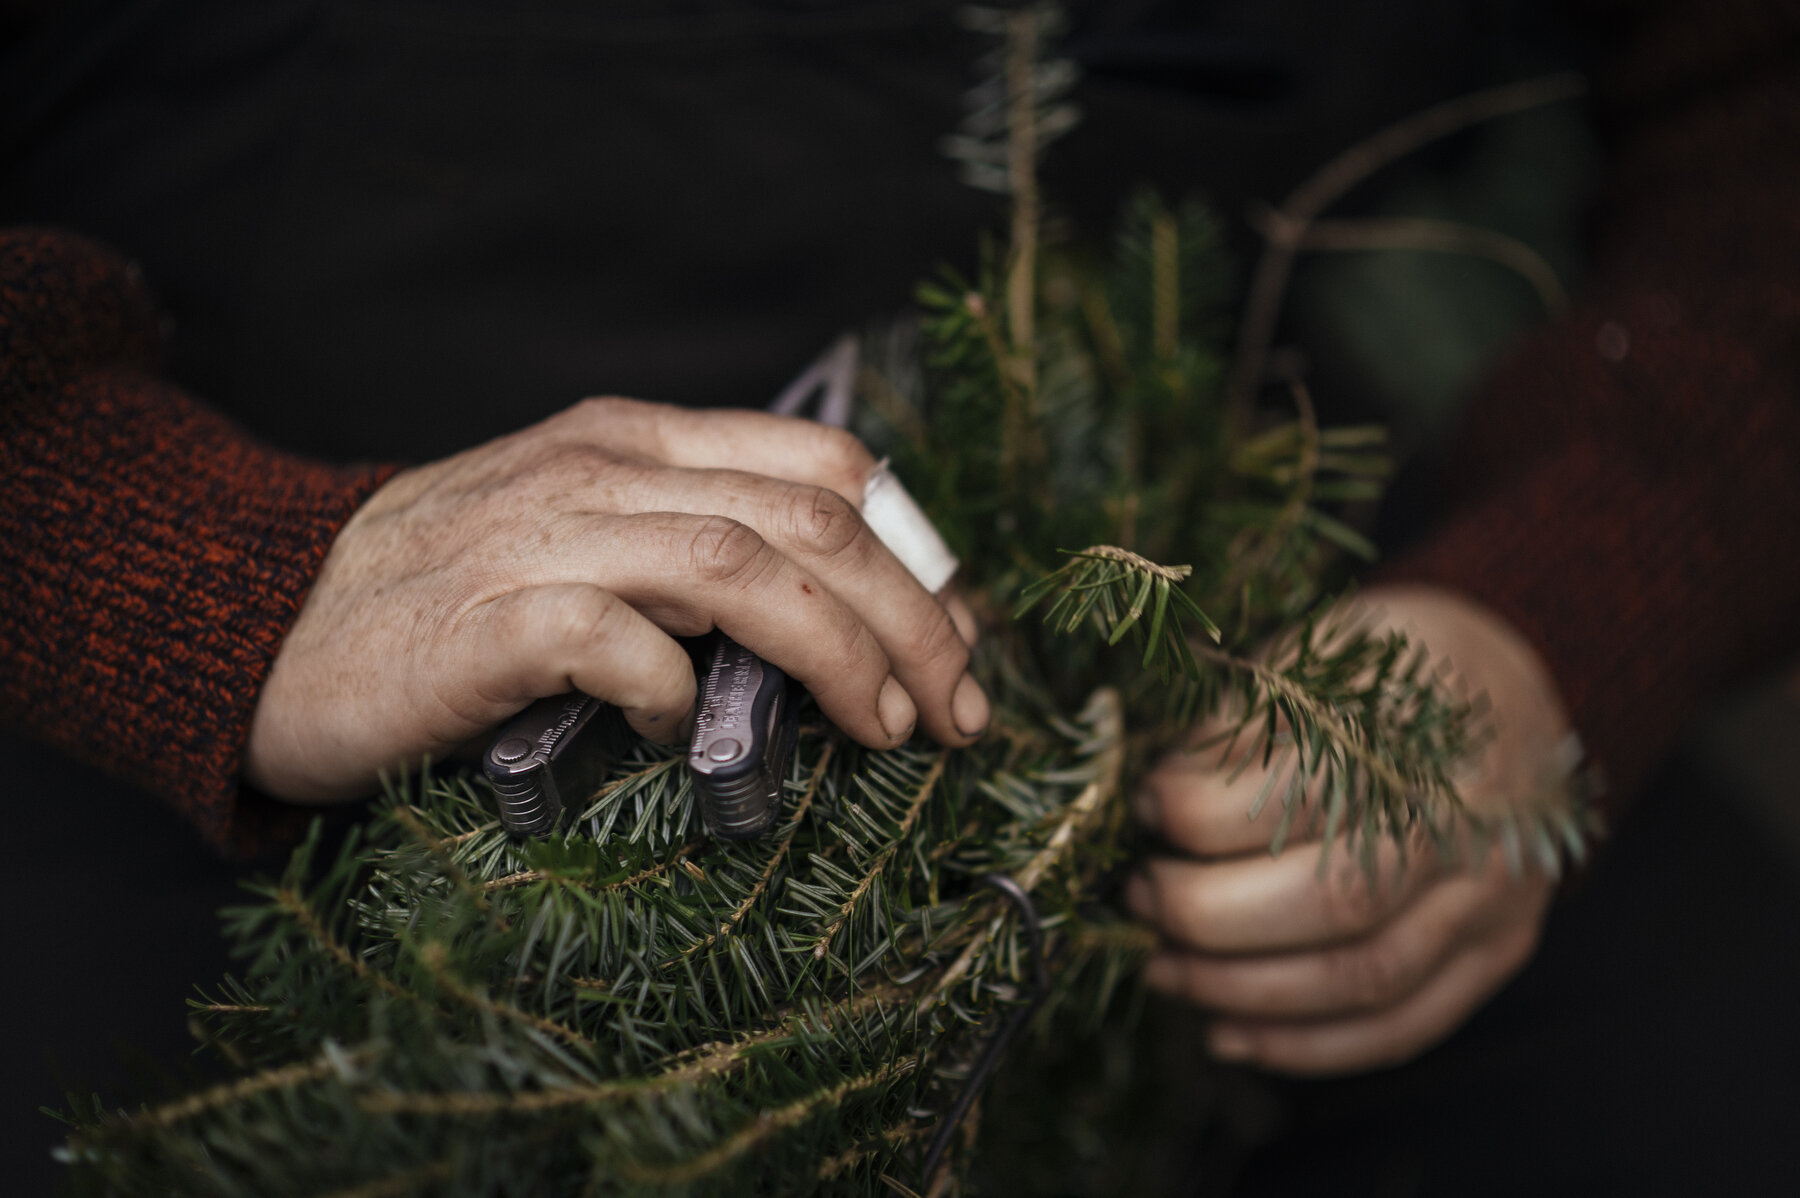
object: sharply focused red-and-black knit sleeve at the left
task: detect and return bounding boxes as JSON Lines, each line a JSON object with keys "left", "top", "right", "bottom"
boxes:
{"left": 0, "top": 230, "right": 391, "bottom": 851}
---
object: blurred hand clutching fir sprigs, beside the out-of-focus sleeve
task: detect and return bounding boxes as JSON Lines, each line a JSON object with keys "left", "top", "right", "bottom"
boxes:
{"left": 1127, "top": 586, "right": 1568, "bottom": 1074}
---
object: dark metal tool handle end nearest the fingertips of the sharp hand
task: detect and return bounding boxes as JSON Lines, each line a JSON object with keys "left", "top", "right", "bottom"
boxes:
{"left": 688, "top": 633, "right": 796, "bottom": 840}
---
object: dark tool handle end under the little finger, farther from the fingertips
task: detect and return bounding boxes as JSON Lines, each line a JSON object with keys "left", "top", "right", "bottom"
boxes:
{"left": 481, "top": 691, "right": 607, "bottom": 840}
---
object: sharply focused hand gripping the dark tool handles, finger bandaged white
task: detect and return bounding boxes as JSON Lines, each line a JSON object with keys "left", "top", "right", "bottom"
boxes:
{"left": 243, "top": 399, "right": 988, "bottom": 802}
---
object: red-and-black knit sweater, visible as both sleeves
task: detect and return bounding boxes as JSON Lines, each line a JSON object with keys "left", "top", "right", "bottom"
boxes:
{"left": 0, "top": 0, "right": 1800, "bottom": 844}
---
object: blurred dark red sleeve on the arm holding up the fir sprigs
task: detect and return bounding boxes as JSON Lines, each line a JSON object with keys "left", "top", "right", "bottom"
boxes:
{"left": 1382, "top": 0, "right": 1800, "bottom": 802}
